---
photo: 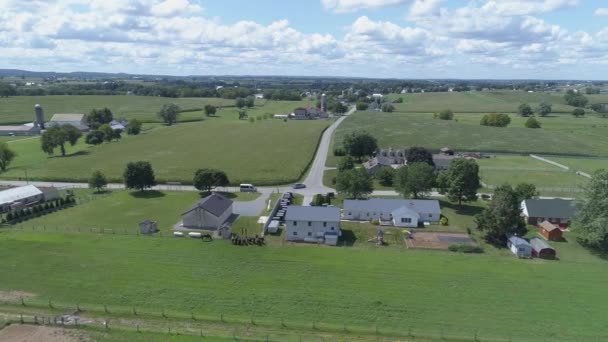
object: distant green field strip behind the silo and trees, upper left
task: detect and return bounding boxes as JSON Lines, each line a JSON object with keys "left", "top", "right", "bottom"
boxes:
{"left": 0, "top": 95, "right": 308, "bottom": 124}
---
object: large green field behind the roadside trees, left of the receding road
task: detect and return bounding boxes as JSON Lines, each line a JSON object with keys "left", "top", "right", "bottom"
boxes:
{"left": 1, "top": 118, "right": 330, "bottom": 185}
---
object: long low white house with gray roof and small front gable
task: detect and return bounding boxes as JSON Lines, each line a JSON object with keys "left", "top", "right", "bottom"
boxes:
{"left": 343, "top": 198, "right": 441, "bottom": 227}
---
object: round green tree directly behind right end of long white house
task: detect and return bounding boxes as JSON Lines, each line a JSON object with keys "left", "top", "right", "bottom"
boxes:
{"left": 395, "top": 162, "right": 436, "bottom": 198}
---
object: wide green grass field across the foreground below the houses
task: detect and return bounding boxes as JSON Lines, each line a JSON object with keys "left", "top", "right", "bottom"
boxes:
{"left": 0, "top": 230, "right": 608, "bottom": 341}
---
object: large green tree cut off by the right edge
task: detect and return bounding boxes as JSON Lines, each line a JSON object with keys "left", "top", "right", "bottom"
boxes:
{"left": 573, "top": 170, "right": 608, "bottom": 252}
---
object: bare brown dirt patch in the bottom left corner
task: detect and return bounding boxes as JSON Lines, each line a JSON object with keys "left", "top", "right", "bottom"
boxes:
{"left": 0, "top": 324, "right": 88, "bottom": 342}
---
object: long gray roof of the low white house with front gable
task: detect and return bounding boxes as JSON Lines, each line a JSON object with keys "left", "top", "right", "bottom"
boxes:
{"left": 344, "top": 198, "right": 441, "bottom": 214}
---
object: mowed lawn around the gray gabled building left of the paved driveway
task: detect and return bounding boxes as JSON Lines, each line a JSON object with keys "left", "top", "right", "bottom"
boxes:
{"left": 16, "top": 191, "right": 259, "bottom": 234}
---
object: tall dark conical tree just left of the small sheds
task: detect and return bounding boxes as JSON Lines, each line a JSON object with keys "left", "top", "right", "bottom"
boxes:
{"left": 475, "top": 185, "right": 527, "bottom": 246}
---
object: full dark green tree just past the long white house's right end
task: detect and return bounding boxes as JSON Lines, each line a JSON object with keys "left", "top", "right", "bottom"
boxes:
{"left": 437, "top": 158, "right": 481, "bottom": 206}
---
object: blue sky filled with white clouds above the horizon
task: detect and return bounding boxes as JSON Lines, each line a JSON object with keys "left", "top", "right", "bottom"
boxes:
{"left": 0, "top": 0, "right": 608, "bottom": 79}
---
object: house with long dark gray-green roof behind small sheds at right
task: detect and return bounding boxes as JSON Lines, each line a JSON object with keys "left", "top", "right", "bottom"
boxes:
{"left": 521, "top": 199, "right": 576, "bottom": 227}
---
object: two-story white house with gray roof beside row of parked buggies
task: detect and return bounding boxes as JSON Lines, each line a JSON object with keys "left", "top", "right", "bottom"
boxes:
{"left": 285, "top": 205, "right": 341, "bottom": 246}
